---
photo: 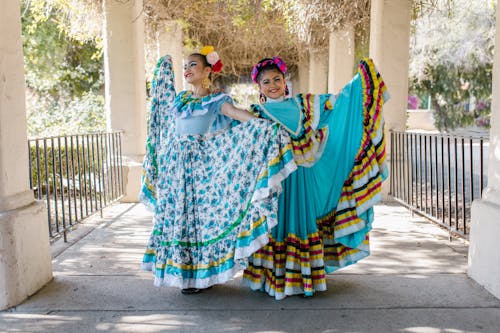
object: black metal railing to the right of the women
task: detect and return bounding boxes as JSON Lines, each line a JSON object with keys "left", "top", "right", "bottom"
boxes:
{"left": 390, "top": 131, "right": 489, "bottom": 238}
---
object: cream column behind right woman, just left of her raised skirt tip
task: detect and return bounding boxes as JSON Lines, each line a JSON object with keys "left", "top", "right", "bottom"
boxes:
{"left": 328, "top": 27, "right": 355, "bottom": 94}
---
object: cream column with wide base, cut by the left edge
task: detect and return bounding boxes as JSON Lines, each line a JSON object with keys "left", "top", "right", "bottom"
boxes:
{"left": 0, "top": 0, "right": 52, "bottom": 309}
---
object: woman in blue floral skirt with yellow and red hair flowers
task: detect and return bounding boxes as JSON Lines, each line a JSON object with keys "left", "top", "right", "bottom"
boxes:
{"left": 140, "top": 47, "right": 296, "bottom": 294}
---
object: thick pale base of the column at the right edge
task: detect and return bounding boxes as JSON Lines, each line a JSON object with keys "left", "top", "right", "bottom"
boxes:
{"left": 468, "top": 192, "right": 500, "bottom": 299}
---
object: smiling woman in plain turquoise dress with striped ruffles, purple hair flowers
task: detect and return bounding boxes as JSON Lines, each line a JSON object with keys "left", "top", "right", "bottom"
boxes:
{"left": 244, "top": 57, "right": 387, "bottom": 299}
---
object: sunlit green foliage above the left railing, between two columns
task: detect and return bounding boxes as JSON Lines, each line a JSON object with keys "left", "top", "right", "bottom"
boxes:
{"left": 22, "top": 0, "right": 105, "bottom": 136}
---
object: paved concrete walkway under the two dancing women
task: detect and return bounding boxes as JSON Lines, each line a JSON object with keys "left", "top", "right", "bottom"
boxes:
{"left": 0, "top": 204, "right": 500, "bottom": 333}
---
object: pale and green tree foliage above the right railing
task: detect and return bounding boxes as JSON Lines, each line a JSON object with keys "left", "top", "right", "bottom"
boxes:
{"left": 409, "top": 0, "right": 495, "bottom": 130}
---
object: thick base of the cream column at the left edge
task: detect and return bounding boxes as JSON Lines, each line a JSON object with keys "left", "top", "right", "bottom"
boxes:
{"left": 0, "top": 201, "right": 52, "bottom": 310}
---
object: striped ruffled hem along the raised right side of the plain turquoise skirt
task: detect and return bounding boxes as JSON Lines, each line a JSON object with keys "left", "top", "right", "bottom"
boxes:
{"left": 317, "top": 59, "right": 387, "bottom": 269}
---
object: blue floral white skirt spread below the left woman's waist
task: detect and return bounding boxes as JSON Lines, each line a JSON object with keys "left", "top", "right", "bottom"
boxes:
{"left": 142, "top": 119, "right": 296, "bottom": 288}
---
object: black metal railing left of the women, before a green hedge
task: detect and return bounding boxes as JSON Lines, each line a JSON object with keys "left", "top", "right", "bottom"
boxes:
{"left": 28, "top": 132, "right": 123, "bottom": 241}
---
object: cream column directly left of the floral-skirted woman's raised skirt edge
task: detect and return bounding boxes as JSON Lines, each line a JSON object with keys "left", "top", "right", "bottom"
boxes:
{"left": 103, "top": 0, "right": 147, "bottom": 202}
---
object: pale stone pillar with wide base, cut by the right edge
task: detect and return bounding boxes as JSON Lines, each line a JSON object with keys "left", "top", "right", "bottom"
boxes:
{"left": 468, "top": 1, "right": 500, "bottom": 298}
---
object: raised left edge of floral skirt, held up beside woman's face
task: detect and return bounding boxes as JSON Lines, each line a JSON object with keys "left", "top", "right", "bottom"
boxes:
{"left": 139, "top": 55, "right": 175, "bottom": 209}
